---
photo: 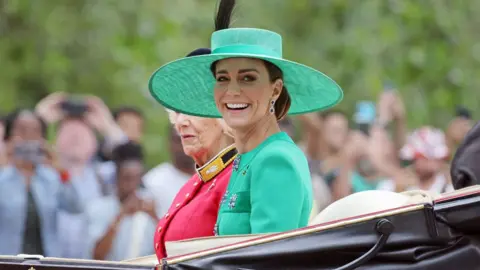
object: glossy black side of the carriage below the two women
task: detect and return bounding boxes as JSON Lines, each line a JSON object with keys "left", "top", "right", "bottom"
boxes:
{"left": 161, "top": 190, "right": 480, "bottom": 270}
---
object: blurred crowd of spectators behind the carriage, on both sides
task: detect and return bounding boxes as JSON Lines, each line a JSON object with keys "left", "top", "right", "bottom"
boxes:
{"left": 0, "top": 89, "right": 472, "bottom": 260}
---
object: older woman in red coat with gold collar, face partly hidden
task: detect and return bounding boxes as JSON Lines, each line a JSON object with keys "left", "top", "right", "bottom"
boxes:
{"left": 155, "top": 49, "right": 237, "bottom": 260}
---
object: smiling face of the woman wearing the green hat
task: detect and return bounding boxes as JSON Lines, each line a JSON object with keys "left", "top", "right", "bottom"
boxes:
{"left": 214, "top": 58, "right": 283, "bottom": 129}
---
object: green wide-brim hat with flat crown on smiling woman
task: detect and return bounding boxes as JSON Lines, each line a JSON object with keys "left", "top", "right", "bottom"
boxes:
{"left": 149, "top": 28, "right": 343, "bottom": 118}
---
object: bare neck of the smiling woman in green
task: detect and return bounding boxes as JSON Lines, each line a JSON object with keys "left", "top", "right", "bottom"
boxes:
{"left": 234, "top": 117, "right": 281, "bottom": 153}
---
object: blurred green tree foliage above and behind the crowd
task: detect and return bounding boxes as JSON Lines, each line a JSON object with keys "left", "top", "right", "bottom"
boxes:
{"left": 0, "top": 0, "right": 480, "bottom": 168}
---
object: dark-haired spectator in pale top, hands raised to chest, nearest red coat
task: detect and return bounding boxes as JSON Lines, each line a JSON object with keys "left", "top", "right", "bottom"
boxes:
{"left": 84, "top": 142, "right": 158, "bottom": 261}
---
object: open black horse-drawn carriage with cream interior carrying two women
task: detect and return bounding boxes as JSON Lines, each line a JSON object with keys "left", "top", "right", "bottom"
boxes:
{"left": 0, "top": 186, "right": 480, "bottom": 270}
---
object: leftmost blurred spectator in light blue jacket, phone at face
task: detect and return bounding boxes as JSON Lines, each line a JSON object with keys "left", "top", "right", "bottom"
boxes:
{"left": 0, "top": 110, "right": 83, "bottom": 256}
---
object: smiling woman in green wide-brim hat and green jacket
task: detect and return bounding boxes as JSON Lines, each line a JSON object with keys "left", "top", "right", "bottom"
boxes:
{"left": 149, "top": 0, "right": 343, "bottom": 235}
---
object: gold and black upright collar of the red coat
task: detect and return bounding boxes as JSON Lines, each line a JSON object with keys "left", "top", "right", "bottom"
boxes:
{"left": 196, "top": 145, "right": 237, "bottom": 183}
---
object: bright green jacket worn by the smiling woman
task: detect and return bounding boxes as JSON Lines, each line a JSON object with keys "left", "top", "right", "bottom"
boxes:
{"left": 215, "top": 132, "right": 313, "bottom": 235}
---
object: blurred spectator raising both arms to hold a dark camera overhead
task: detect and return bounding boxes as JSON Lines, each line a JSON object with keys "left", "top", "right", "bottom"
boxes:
{"left": 36, "top": 92, "right": 128, "bottom": 258}
